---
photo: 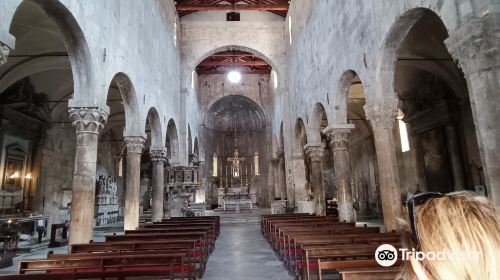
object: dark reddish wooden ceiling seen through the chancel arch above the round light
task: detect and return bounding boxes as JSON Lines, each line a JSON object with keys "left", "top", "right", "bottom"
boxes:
{"left": 196, "top": 51, "right": 272, "bottom": 75}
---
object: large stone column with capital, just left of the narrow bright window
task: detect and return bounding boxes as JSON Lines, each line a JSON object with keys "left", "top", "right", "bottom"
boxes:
{"left": 365, "top": 100, "right": 402, "bottom": 231}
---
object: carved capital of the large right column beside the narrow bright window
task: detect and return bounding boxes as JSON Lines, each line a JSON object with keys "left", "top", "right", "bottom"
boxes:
{"left": 364, "top": 100, "right": 398, "bottom": 130}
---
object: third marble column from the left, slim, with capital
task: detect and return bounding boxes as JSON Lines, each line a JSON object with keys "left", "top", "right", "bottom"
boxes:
{"left": 150, "top": 150, "right": 167, "bottom": 222}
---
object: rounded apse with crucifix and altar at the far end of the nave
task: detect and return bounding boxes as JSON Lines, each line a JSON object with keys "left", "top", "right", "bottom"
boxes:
{"left": 204, "top": 95, "right": 270, "bottom": 207}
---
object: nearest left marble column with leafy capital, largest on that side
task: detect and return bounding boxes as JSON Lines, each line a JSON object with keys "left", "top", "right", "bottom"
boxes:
{"left": 64, "top": 108, "right": 108, "bottom": 245}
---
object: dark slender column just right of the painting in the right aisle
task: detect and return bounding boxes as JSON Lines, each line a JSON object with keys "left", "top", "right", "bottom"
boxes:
{"left": 445, "top": 124, "right": 465, "bottom": 191}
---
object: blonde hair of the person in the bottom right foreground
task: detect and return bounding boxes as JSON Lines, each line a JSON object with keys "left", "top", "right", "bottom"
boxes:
{"left": 402, "top": 191, "right": 500, "bottom": 280}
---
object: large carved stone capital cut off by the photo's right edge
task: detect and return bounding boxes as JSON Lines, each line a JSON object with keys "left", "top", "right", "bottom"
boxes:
{"left": 445, "top": 18, "right": 500, "bottom": 74}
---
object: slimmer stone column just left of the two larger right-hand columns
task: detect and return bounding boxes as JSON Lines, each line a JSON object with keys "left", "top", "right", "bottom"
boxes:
{"left": 304, "top": 144, "right": 326, "bottom": 216}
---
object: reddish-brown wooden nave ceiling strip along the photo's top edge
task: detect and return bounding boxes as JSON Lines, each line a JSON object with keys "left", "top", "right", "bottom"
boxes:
{"left": 175, "top": 0, "right": 289, "bottom": 17}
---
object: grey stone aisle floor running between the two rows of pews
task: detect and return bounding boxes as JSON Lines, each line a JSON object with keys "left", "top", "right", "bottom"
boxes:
{"left": 203, "top": 222, "right": 292, "bottom": 280}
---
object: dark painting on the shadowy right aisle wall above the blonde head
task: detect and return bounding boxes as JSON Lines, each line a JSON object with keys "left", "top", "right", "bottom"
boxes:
{"left": 420, "top": 126, "right": 453, "bottom": 192}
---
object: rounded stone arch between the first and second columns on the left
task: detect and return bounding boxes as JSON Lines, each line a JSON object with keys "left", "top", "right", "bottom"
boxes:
{"left": 108, "top": 72, "right": 144, "bottom": 136}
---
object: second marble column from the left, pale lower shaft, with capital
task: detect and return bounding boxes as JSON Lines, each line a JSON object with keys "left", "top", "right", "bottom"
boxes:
{"left": 124, "top": 136, "right": 145, "bottom": 230}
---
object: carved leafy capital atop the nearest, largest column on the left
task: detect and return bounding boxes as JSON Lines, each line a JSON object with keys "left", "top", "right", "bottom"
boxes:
{"left": 68, "top": 107, "right": 108, "bottom": 134}
